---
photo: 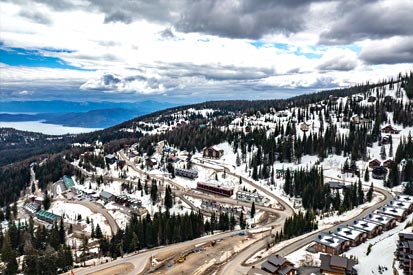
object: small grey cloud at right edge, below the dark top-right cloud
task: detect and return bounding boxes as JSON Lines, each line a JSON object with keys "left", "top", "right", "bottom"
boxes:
{"left": 360, "top": 36, "right": 413, "bottom": 64}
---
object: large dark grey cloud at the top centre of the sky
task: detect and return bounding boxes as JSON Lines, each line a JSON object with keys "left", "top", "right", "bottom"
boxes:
{"left": 175, "top": 0, "right": 309, "bottom": 39}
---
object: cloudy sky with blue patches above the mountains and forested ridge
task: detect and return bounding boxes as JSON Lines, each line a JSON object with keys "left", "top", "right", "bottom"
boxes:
{"left": 0, "top": 0, "right": 413, "bottom": 103}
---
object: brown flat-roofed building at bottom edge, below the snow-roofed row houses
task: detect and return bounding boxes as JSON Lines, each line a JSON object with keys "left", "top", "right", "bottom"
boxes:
{"left": 320, "top": 254, "right": 357, "bottom": 275}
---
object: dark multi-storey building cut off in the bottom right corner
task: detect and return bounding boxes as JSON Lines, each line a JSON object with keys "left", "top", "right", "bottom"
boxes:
{"left": 396, "top": 233, "right": 413, "bottom": 275}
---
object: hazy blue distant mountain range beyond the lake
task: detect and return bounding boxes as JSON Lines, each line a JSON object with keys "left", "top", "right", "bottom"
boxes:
{"left": 0, "top": 100, "right": 176, "bottom": 128}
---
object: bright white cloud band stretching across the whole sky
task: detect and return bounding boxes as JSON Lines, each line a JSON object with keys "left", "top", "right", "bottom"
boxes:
{"left": 0, "top": 1, "right": 411, "bottom": 99}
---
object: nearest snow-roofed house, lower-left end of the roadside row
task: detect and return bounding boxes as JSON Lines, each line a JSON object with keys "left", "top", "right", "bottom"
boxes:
{"left": 315, "top": 232, "right": 350, "bottom": 255}
